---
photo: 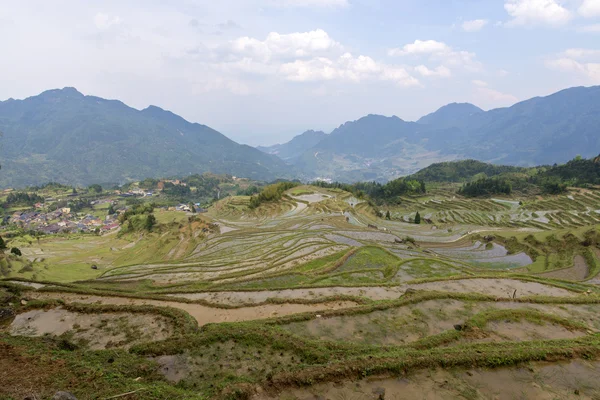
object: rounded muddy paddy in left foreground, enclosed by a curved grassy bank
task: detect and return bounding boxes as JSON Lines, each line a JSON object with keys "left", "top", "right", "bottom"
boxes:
{"left": 8, "top": 308, "right": 172, "bottom": 350}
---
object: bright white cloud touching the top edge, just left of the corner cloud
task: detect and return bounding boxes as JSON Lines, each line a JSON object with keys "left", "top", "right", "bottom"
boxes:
{"left": 504, "top": 0, "right": 571, "bottom": 25}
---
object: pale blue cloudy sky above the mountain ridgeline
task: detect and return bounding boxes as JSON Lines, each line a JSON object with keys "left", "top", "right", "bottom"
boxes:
{"left": 0, "top": 0, "right": 600, "bottom": 145}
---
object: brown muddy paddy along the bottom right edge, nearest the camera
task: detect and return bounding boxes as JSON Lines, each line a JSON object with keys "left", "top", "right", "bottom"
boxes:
{"left": 254, "top": 360, "right": 600, "bottom": 400}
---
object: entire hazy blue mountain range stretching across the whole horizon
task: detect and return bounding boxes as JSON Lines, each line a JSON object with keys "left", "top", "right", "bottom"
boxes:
{"left": 0, "top": 86, "right": 600, "bottom": 187}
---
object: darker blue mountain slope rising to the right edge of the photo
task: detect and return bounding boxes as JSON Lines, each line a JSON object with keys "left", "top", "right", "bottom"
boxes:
{"left": 447, "top": 86, "right": 600, "bottom": 166}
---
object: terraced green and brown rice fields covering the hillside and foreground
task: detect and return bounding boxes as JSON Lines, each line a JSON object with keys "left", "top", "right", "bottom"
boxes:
{"left": 0, "top": 187, "right": 600, "bottom": 399}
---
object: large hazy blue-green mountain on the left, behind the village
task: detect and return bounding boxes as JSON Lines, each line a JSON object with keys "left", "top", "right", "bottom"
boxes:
{"left": 0, "top": 88, "right": 290, "bottom": 187}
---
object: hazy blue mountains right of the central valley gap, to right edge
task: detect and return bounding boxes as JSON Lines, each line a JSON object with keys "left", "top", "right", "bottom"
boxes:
{"left": 284, "top": 86, "right": 600, "bottom": 181}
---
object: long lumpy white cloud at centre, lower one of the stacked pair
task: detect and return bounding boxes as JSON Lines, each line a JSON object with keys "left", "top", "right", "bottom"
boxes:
{"left": 279, "top": 53, "right": 419, "bottom": 86}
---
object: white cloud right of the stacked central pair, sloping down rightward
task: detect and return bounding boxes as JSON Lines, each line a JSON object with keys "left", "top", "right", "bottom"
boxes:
{"left": 388, "top": 40, "right": 481, "bottom": 72}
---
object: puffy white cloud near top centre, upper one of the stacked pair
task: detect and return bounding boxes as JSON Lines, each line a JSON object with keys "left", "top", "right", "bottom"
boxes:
{"left": 231, "top": 29, "right": 341, "bottom": 60}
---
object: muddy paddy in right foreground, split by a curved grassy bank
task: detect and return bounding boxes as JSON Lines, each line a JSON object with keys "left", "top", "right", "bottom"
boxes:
{"left": 282, "top": 299, "right": 600, "bottom": 345}
